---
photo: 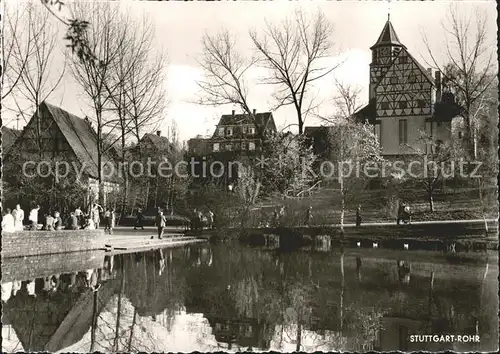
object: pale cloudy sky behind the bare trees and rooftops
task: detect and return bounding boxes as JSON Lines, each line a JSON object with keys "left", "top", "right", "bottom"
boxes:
{"left": 2, "top": 0, "right": 496, "bottom": 144}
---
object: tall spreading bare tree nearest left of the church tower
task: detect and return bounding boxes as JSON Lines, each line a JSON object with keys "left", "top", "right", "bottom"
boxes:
{"left": 250, "top": 10, "right": 338, "bottom": 134}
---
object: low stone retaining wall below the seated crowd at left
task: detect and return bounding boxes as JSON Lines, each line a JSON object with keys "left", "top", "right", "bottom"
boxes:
{"left": 2, "top": 230, "right": 104, "bottom": 258}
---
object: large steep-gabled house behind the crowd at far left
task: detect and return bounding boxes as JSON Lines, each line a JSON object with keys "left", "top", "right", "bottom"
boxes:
{"left": 4, "top": 101, "right": 121, "bottom": 209}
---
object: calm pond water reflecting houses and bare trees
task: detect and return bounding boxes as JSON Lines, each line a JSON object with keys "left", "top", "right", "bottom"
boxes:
{"left": 2, "top": 244, "right": 498, "bottom": 352}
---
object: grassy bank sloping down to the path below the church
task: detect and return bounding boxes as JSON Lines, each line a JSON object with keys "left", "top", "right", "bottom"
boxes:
{"left": 249, "top": 188, "right": 498, "bottom": 226}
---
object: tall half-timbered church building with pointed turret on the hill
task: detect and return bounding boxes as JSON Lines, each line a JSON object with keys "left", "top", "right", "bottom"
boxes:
{"left": 353, "top": 15, "right": 460, "bottom": 156}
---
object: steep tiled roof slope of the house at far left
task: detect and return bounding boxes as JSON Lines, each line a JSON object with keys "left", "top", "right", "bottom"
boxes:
{"left": 40, "top": 102, "right": 116, "bottom": 178}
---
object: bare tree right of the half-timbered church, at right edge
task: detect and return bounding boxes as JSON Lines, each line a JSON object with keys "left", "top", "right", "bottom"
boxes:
{"left": 424, "top": 5, "right": 497, "bottom": 158}
